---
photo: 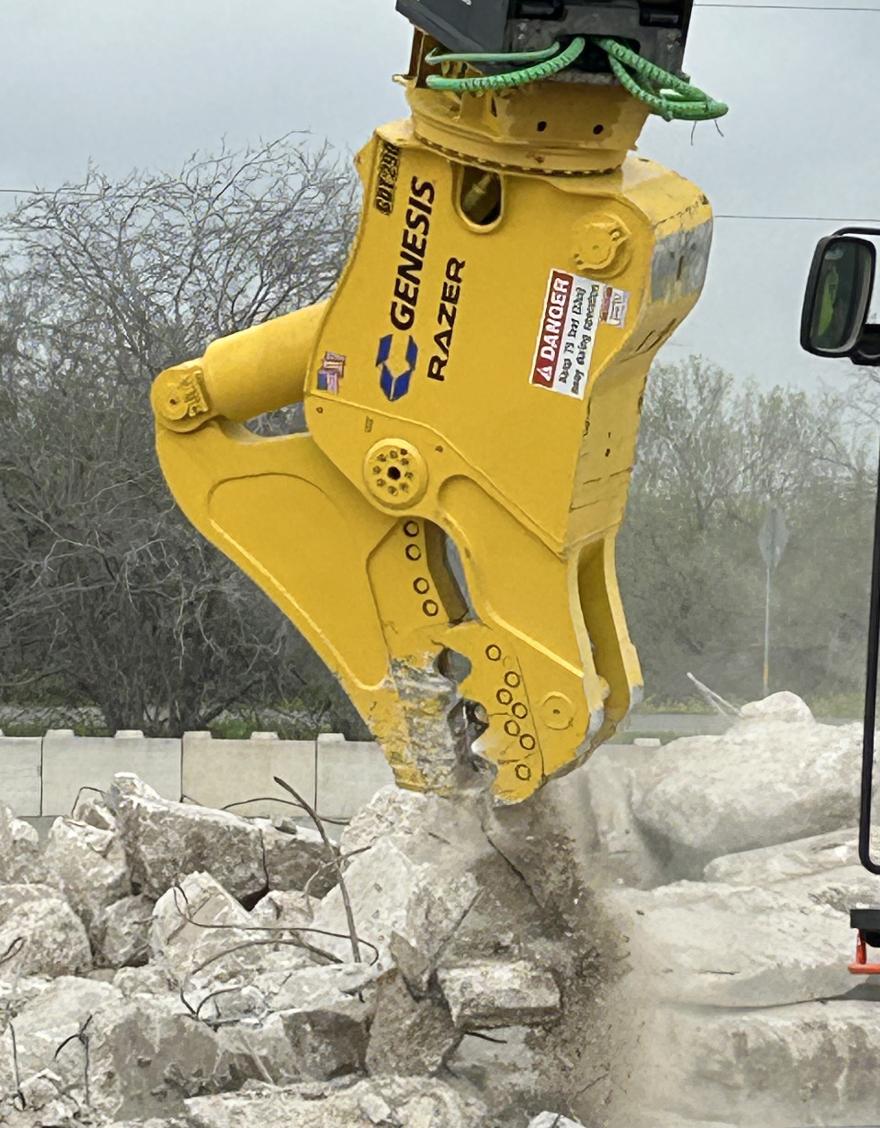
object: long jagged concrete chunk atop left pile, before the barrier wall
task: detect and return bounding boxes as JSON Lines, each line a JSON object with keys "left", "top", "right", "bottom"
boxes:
{"left": 108, "top": 773, "right": 267, "bottom": 899}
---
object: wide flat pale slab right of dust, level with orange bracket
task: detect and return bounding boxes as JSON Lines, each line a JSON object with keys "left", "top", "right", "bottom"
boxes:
{"left": 605, "top": 881, "right": 852, "bottom": 1007}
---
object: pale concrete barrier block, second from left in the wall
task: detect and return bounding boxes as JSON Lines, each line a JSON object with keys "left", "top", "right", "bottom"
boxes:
{"left": 41, "top": 729, "right": 181, "bottom": 816}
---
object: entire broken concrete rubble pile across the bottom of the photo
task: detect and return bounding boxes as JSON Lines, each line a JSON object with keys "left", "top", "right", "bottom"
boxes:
{"left": 0, "top": 694, "right": 880, "bottom": 1128}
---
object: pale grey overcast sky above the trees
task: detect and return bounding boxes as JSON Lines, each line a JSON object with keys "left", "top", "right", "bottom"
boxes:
{"left": 0, "top": 0, "right": 880, "bottom": 387}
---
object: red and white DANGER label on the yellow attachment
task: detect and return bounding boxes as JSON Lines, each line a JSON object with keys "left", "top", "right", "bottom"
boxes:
{"left": 531, "top": 271, "right": 613, "bottom": 399}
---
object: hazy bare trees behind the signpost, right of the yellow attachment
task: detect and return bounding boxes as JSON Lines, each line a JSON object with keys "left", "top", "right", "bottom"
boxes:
{"left": 618, "top": 356, "right": 873, "bottom": 700}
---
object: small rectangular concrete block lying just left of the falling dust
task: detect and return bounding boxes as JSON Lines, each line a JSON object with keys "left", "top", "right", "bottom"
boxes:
{"left": 437, "top": 960, "right": 561, "bottom": 1030}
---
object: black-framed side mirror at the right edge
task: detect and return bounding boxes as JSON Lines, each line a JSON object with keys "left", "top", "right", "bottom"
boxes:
{"left": 801, "top": 233, "right": 877, "bottom": 356}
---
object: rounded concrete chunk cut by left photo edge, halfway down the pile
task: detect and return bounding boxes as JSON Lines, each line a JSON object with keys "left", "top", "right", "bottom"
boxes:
{"left": 0, "top": 885, "right": 91, "bottom": 981}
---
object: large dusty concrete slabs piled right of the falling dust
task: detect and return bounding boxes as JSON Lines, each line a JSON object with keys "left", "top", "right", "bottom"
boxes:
{"left": 595, "top": 693, "right": 880, "bottom": 1128}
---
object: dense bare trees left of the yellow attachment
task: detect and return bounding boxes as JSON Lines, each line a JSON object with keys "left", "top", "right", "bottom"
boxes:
{"left": 0, "top": 138, "right": 363, "bottom": 733}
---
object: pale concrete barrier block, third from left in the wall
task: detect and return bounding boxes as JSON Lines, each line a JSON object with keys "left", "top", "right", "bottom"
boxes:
{"left": 183, "top": 732, "right": 315, "bottom": 818}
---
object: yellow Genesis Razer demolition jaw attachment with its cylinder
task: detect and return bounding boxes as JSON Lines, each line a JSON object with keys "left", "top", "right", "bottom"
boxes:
{"left": 153, "top": 37, "right": 711, "bottom": 802}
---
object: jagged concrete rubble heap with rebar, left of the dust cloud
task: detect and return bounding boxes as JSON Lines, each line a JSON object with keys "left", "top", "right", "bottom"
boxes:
{"left": 0, "top": 774, "right": 600, "bottom": 1128}
